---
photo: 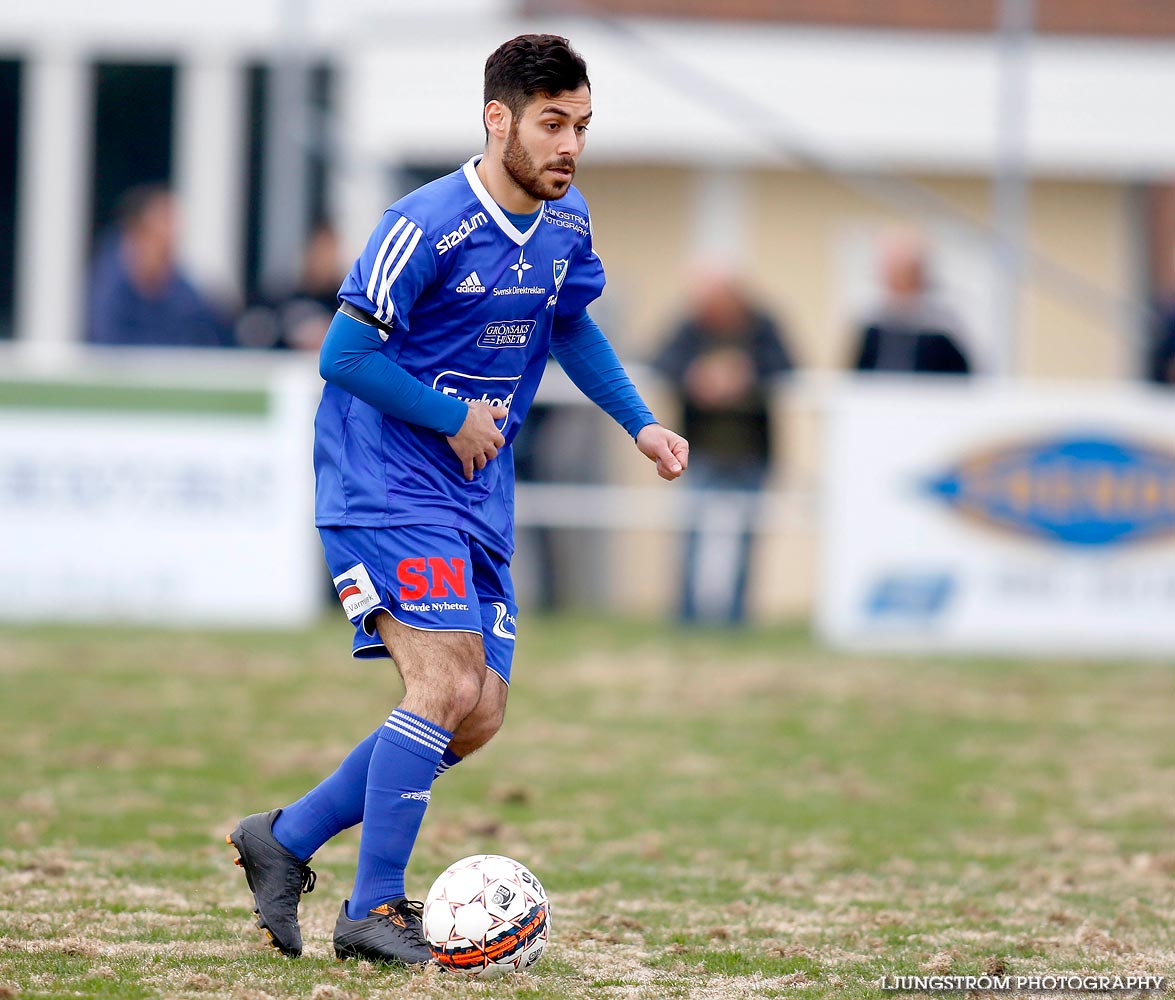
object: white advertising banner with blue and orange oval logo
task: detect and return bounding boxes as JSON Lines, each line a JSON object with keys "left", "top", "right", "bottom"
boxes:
{"left": 817, "top": 378, "right": 1175, "bottom": 655}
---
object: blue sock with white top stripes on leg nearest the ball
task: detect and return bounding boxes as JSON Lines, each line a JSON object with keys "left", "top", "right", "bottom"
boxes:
{"left": 347, "top": 709, "right": 452, "bottom": 920}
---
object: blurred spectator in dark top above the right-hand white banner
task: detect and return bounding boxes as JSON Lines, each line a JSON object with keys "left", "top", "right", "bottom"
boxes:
{"left": 853, "top": 234, "right": 971, "bottom": 375}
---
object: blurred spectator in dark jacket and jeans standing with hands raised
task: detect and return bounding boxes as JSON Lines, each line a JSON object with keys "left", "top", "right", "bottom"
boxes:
{"left": 652, "top": 270, "right": 792, "bottom": 624}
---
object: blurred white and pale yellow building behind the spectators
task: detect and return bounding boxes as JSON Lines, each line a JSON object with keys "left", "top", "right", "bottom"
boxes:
{"left": 0, "top": 0, "right": 1175, "bottom": 625}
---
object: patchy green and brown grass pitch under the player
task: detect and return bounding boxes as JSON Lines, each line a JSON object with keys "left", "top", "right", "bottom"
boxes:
{"left": 0, "top": 618, "right": 1175, "bottom": 1000}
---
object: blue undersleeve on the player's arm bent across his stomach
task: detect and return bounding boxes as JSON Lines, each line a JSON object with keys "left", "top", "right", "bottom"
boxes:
{"left": 318, "top": 308, "right": 469, "bottom": 436}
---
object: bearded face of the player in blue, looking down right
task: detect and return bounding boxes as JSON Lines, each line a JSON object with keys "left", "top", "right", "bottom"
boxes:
{"left": 502, "top": 87, "right": 591, "bottom": 201}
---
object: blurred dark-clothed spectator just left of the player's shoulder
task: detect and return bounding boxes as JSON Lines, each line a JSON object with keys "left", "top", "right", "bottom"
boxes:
{"left": 236, "top": 222, "right": 345, "bottom": 351}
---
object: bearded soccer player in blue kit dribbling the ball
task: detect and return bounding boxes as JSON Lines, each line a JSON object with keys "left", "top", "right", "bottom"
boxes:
{"left": 228, "top": 35, "right": 689, "bottom": 965}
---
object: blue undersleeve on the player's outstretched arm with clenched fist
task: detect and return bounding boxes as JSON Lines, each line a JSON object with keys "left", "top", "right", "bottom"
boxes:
{"left": 551, "top": 309, "right": 657, "bottom": 437}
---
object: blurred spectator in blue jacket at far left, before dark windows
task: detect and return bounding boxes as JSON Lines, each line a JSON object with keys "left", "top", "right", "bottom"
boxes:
{"left": 86, "top": 184, "right": 231, "bottom": 347}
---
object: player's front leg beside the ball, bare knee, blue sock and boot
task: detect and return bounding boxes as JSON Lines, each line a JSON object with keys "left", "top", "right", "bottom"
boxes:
{"left": 335, "top": 613, "right": 485, "bottom": 964}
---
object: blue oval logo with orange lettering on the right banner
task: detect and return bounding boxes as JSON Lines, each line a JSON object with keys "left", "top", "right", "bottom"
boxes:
{"left": 924, "top": 435, "right": 1175, "bottom": 548}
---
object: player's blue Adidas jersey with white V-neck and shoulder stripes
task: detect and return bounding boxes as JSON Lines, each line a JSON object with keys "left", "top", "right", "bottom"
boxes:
{"left": 314, "top": 156, "right": 604, "bottom": 557}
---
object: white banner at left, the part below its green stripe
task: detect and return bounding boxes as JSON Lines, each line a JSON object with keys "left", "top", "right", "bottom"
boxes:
{"left": 0, "top": 378, "right": 325, "bottom": 626}
